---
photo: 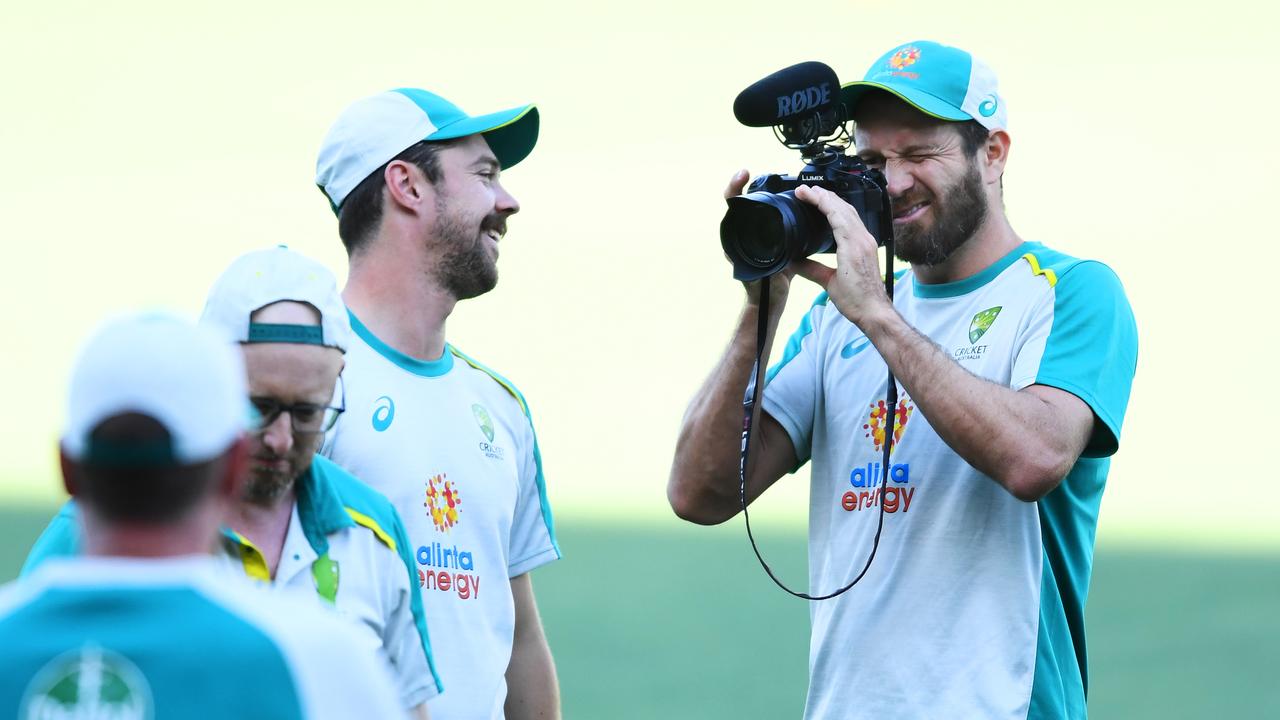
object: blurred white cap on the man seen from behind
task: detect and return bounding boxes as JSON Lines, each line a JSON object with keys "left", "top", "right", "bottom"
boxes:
{"left": 61, "top": 313, "right": 250, "bottom": 465}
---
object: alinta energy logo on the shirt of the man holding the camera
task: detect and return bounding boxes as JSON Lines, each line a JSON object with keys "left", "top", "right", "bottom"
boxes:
{"left": 840, "top": 393, "right": 915, "bottom": 512}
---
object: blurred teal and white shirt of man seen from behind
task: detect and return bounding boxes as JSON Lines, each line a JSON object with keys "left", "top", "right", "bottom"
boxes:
{"left": 0, "top": 556, "right": 404, "bottom": 720}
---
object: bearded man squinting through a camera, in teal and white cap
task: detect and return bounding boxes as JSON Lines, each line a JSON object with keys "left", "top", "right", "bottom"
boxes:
{"left": 668, "top": 42, "right": 1137, "bottom": 719}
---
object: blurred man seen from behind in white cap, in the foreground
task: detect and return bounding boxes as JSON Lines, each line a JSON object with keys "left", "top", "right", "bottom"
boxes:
{"left": 0, "top": 314, "right": 403, "bottom": 720}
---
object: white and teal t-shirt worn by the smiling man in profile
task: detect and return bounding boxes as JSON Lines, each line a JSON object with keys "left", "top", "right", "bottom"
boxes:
{"left": 323, "top": 310, "right": 561, "bottom": 720}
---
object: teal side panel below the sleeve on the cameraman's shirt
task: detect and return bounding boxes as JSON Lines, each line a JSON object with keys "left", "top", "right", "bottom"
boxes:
{"left": 1030, "top": 457, "right": 1111, "bottom": 719}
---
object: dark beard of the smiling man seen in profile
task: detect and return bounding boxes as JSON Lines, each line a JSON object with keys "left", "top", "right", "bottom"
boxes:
{"left": 435, "top": 196, "right": 507, "bottom": 300}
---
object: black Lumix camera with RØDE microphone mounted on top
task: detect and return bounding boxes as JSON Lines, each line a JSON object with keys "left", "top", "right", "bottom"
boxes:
{"left": 721, "top": 61, "right": 893, "bottom": 281}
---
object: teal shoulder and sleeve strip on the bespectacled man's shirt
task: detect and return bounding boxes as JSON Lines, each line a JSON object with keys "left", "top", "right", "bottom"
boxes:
{"left": 311, "top": 455, "right": 444, "bottom": 692}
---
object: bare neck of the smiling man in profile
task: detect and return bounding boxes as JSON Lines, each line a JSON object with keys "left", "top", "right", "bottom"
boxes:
{"left": 342, "top": 228, "right": 457, "bottom": 360}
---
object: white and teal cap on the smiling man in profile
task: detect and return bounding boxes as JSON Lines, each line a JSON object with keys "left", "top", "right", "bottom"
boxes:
{"left": 316, "top": 87, "right": 538, "bottom": 213}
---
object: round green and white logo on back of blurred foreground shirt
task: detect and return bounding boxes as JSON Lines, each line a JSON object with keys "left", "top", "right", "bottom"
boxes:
{"left": 18, "top": 644, "right": 154, "bottom": 720}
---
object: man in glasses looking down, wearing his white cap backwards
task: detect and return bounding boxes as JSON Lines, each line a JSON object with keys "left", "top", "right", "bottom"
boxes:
{"left": 28, "top": 247, "right": 440, "bottom": 716}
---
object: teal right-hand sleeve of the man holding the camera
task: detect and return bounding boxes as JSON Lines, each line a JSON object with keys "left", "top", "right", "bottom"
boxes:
{"left": 1032, "top": 246, "right": 1138, "bottom": 457}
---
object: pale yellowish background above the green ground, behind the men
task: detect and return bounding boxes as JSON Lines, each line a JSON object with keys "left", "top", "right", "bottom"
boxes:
{"left": 0, "top": 0, "right": 1280, "bottom": 547}
